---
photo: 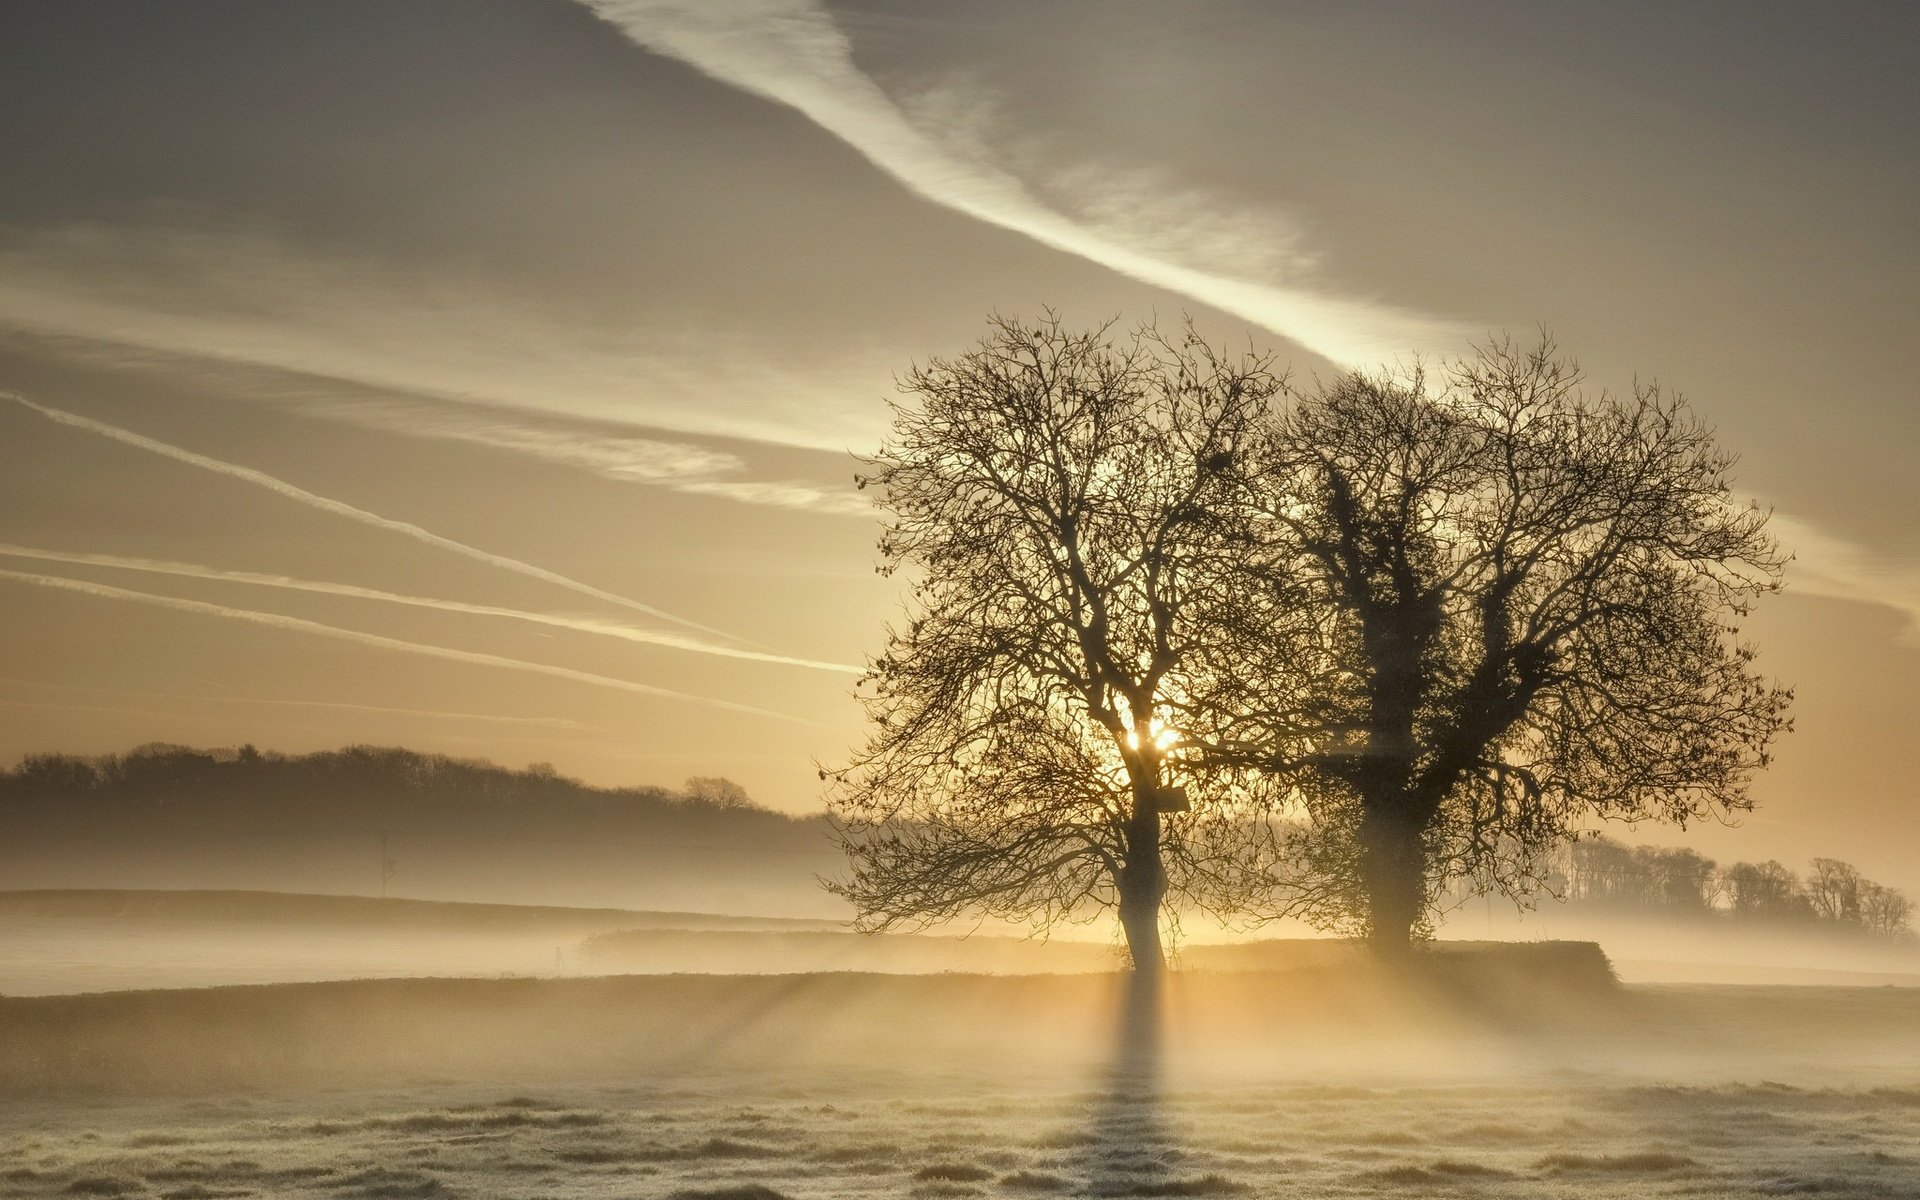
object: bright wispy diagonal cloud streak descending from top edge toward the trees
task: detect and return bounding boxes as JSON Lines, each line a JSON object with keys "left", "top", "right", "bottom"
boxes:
{"left": 582, "top": 0, "right": 1457, "bottom": 367}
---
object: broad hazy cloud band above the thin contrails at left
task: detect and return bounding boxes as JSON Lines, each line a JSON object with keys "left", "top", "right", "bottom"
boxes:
{"left": 0, "top": 223, "right": 883, "bottom": 453}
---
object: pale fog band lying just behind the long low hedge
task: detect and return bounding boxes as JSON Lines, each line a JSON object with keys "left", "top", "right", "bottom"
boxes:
{"left": 0, "top": 889, "right": 1920, "bottom": 996}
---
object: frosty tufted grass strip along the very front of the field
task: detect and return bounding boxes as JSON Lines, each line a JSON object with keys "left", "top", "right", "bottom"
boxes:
{"left": 0, "top": 1069, "right": 1920, "bottom": 1200}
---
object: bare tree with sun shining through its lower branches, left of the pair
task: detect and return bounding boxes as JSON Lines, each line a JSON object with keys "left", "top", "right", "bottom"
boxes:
{"left": 822, "top": 315, "right": 1281, "bottom": 975}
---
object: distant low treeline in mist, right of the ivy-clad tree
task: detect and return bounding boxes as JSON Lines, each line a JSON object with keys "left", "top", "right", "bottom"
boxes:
{"left": 1548, "top": 837, "right": 1914, "bottom": 937}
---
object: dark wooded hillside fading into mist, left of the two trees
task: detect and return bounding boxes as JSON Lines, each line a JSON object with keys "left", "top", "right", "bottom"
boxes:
{"left": 0, "top": 745, "right": 841, "bottom": 916}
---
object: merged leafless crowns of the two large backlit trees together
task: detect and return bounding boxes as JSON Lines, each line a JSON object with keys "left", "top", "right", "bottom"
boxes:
{"left": 822, "top": 315, "right": 1791, "bottom": 968}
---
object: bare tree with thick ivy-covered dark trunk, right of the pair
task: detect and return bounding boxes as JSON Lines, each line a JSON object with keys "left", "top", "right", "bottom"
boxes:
{"left": 1215, "top": 340, "right": 1789, "bottom": 950}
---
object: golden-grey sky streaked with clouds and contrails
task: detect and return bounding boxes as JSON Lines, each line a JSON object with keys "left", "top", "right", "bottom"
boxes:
{"left": 0, "top": 0, "right": 1920, "bottom": 889}
